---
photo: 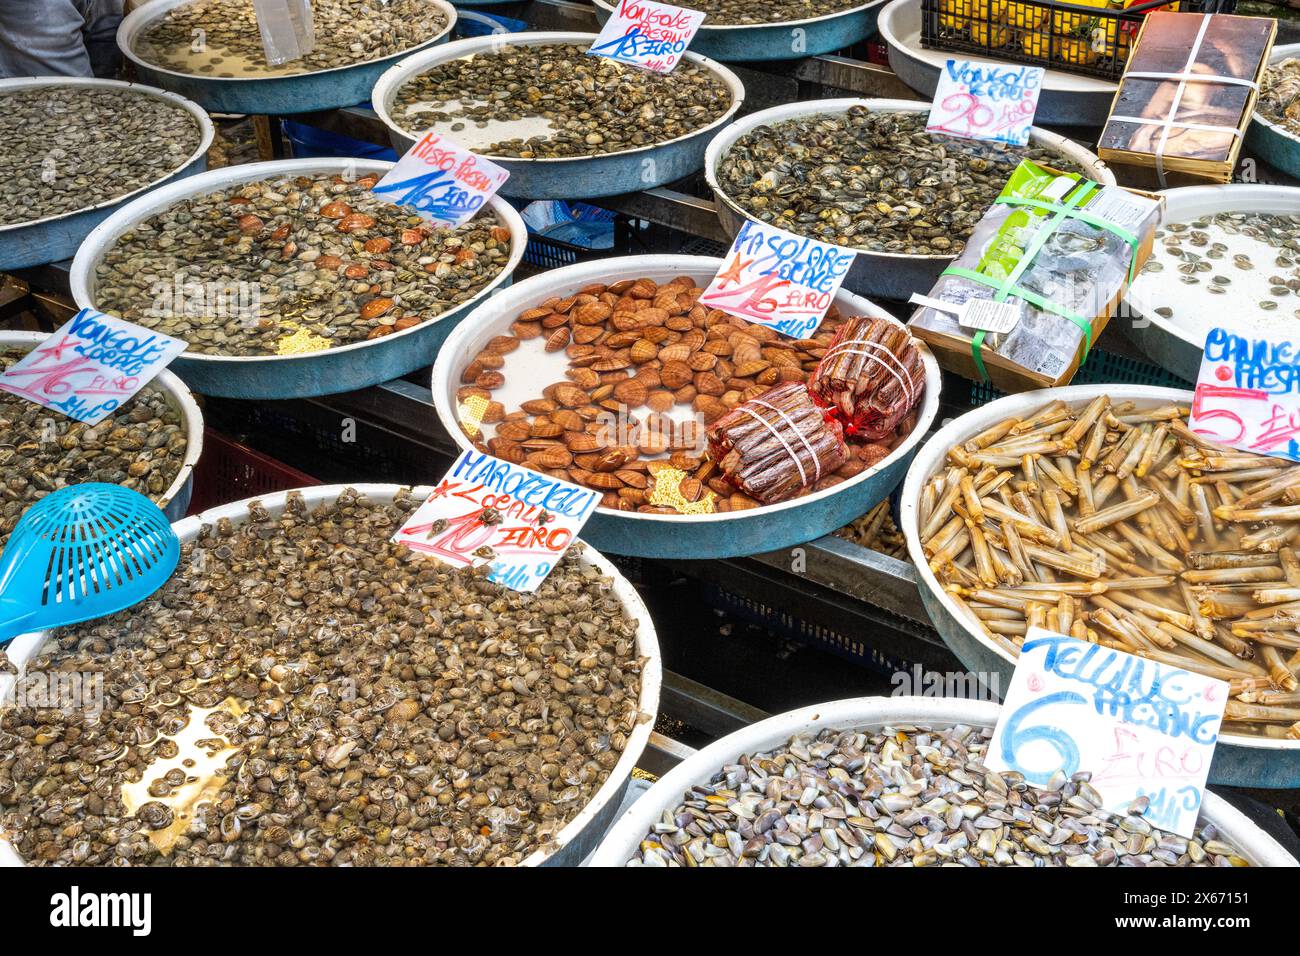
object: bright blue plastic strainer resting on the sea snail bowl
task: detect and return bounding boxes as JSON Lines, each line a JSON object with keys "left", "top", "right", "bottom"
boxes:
{"left": 0, "top": 483, "right": 181, "bottom": 646}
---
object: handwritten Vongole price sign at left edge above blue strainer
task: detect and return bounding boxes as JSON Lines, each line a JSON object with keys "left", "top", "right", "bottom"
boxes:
{"left": 0, "top": 308, "right": 186, "bottom": 425}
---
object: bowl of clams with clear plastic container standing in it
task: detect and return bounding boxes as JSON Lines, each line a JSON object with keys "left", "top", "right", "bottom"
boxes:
{"left": 117, "top": 0, "right": 456, "bottom": 114}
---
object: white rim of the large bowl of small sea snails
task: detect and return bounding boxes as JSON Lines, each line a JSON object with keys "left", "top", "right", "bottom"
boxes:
{"left": 0, "top": 484, "right": 663, "bottom": 866}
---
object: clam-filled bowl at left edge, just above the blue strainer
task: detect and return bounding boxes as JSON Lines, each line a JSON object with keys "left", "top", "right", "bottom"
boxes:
{"left": 0, "top": 330, "right": 203, "bottom": 535}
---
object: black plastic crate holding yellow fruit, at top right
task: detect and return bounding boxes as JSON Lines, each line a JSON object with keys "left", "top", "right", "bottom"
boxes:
{"left": 920, "top": 0, "right": 1236, "bottom": 81}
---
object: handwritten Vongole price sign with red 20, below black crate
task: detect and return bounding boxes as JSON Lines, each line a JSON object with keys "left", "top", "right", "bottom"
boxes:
{"left": 926, "top": 60, "right": 1043, "bottom": 146}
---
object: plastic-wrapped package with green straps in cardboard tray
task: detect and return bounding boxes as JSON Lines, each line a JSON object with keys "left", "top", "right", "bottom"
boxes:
{"left": 911, "top": 160, "right": 1162, "bottom": 392}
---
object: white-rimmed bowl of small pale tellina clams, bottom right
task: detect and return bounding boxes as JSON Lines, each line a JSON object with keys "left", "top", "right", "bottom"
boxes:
{"left": 592, "top": 697, "right": 1296, "bottom": 866}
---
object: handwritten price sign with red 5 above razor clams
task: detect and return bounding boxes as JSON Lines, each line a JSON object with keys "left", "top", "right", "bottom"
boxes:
{"left": 1188, "top": 328, "right": 1300, "bottom": 462}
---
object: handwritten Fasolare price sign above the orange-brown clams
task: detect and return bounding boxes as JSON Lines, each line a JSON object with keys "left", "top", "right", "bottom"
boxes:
{"left": 699, "top": 220, "right": 857, "bottom": 338}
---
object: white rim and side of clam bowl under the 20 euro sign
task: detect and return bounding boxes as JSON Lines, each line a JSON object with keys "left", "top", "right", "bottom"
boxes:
{"left": 705, "top": 99, "right": 1115, "bottom": 302}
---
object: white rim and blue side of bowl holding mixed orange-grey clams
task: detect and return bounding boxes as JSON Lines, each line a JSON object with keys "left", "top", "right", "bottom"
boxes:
{"left": 70, "top": 159, "right": 528, "bottom": 398}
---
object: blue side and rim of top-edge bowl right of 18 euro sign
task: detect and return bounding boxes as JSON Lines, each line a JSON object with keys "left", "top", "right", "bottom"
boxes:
{"left": 592, "top": 0, "right": 885, "bottom": 62}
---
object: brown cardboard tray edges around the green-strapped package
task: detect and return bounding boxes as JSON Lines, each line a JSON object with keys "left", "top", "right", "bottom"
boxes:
{"left": 907, "top": 166, "right": 1165, "bottom": 393}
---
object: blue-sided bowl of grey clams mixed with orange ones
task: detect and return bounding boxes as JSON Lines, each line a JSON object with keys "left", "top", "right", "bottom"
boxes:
{"left": 72, "top": 159, "right": 527, "bottom": 398}
